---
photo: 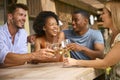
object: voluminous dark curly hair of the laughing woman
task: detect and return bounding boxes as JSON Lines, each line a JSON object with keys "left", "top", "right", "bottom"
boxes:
{"left": 33, "top": 11, "right": 59, "bottom": 36}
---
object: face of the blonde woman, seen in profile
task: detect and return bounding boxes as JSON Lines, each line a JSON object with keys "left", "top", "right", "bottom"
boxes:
{"left": 101, "top": 8, "right": 113, "bottom": 28}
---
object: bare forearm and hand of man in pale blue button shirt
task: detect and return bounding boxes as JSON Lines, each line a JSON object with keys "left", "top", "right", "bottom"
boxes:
{"left": 0, "top": 49, "right": 54, "bottom": 67}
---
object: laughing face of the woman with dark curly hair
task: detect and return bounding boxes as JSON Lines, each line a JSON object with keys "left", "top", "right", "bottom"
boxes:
{"left": 44, "top": 17, "right": 59, "bottom": 36}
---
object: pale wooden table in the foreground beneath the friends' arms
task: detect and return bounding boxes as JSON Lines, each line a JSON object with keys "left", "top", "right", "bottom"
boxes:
{"left": 0, "top": 63, "right": 103, "bottom": 80}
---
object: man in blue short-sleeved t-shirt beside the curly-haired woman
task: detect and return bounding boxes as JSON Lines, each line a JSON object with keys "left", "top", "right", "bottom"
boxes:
{"left": 64, "top": 10, "right": 104, "bottom": 60}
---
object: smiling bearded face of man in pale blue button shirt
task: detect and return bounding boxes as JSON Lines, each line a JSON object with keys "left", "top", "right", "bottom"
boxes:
{"left": 8, "top": 8, "right": 27, "bottom": 28}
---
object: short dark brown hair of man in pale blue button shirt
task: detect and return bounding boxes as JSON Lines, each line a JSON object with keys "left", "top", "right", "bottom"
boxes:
{"left": 7, "top": 3, "right": 28, "bottom": 13}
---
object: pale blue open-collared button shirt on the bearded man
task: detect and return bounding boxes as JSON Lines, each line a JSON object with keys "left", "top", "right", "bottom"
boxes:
{"left": 0, "top": 23, "right": 27, "bottom": 63}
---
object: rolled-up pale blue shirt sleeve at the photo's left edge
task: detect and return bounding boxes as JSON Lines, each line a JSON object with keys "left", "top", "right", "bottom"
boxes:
{"left": 0, "top": 31, "right": 9, "bottom": 63}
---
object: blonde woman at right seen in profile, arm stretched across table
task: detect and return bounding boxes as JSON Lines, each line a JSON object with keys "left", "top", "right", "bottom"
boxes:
{"left": 64, "top": 0, "right": 120, "bottom": 80}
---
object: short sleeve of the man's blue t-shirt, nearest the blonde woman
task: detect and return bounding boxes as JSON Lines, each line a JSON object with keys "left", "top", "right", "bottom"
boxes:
{"left": 93, "top": 30, "right": 104, "bottom": 44}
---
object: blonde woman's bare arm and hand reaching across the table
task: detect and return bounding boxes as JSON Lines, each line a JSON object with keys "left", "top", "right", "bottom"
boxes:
{"left": 64, "top": 42, "right": 120, "bottom": 68}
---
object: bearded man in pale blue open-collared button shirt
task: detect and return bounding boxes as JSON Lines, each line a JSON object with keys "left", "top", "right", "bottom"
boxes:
{"left": 0, "top": 3, "right": 54, "bottom": 67}
